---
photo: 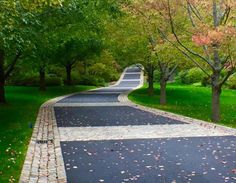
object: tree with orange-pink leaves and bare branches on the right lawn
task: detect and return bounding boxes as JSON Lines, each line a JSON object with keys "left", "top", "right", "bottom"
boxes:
{"left": 159, "top": 0, "right": 236, "bottom": 122}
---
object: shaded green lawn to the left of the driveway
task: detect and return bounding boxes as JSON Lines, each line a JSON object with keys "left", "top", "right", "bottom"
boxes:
{"left": 0, "top": 86, "right": 96, "bottom": 183}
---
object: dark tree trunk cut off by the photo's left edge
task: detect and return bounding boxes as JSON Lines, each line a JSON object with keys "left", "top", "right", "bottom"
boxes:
{"left": 0, "top": 50, "right": 6, "bottom": 103}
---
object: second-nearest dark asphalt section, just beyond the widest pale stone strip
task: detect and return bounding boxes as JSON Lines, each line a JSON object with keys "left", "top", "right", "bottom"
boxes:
{"left": 54, "top": 106, "right": 185, "bottom": 127}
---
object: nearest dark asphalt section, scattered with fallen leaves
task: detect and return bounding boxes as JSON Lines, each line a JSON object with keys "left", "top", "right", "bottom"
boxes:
{"left": 61, "top": 136, "right": 236, "bottom": 183}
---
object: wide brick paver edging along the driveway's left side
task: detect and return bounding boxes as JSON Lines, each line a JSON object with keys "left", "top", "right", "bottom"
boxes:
{"left": 19, "top": 93, "right": 79, "bottom": 183}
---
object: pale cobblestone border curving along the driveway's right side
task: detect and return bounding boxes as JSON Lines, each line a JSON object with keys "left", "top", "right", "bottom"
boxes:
{"left": 118, "top": 72, "right": 236, "bottom": 136}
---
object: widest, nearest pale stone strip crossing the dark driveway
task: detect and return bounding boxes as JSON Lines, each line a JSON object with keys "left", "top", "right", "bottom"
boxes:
{"left": 59, "top": 124, "right": 230, "bottom": 141}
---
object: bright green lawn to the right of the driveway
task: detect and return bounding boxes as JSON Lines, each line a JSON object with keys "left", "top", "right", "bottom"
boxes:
{"left": 129, "top": 83, "right": 236, "bottom": 128}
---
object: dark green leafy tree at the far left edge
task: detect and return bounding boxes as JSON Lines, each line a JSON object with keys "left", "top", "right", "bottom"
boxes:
{"left": 0, "top": 0, "right": 61, "bottom": 103}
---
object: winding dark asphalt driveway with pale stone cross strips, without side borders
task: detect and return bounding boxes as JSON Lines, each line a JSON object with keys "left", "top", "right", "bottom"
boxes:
{"left": 54, "top": 67, "right": 236, "bottom": 183}
